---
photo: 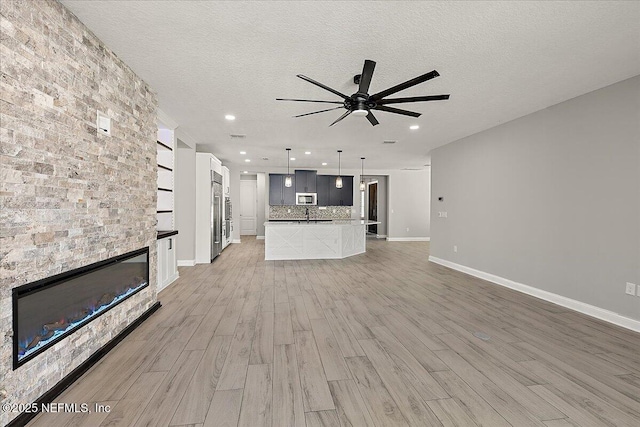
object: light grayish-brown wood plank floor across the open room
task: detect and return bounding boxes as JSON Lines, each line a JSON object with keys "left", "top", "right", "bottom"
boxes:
{"left": 30, "top": 236, "right": 640, "bottom": 427}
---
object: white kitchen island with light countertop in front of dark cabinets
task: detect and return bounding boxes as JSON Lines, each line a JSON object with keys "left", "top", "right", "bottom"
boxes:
{"left": 264, "top": 220, "right": 379, "bottom": 260}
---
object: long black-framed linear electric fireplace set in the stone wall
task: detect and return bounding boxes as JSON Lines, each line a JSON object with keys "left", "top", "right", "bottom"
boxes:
{"left": 13, "top": 247, "right": 149, "bottom": 369}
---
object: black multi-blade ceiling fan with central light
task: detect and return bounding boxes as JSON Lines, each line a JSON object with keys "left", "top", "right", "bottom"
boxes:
{"left": 276, "top": 59, "right": 449, "bottom": 126}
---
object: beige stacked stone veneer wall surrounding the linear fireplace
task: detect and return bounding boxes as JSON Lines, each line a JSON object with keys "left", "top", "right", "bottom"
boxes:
{"left": 0, "top": 0, "right": 157, "bottom": 425}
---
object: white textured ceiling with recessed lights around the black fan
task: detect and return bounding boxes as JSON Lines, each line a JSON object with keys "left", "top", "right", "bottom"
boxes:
{"left": 62, "top": 0, "right": 640, "bottom": 171}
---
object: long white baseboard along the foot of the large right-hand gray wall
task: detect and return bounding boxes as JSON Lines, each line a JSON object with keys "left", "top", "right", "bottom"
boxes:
{"left": 429, "top": 256, "right": 640, "bottom": 332}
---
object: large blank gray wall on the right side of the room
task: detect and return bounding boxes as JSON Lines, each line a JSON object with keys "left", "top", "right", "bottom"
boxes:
{"left": 431, "top": 76, "right": 640, "bottom": 320}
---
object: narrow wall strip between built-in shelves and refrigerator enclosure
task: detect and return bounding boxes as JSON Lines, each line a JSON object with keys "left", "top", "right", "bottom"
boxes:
{"left": 174, "top": 139, "right": 196, "bottom": 263}
